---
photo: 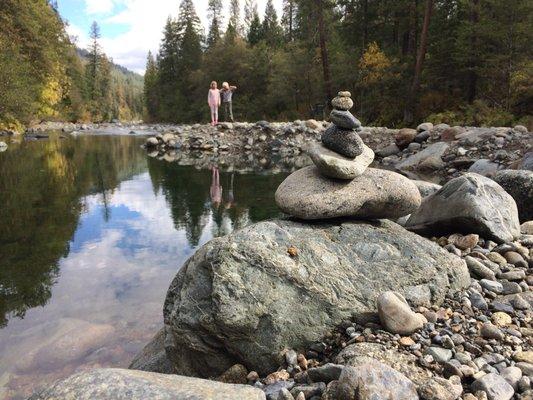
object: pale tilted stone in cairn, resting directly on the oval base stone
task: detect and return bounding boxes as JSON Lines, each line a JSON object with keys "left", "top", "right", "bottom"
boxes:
{"left": 307, "top": 143, "right": 374, "bottom": 179}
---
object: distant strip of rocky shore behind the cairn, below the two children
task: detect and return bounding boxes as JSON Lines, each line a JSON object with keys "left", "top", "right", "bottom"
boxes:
{"left": 139, "top": 120, "right": 533, "bottom": 182}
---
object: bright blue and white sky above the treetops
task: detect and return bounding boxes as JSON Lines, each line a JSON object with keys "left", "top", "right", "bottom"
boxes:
{"left": 57, "top": 0, "right": 282, "bottom": 74}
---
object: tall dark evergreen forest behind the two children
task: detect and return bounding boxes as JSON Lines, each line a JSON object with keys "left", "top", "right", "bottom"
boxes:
{"left": 145, "top": 0, "right": 533, "bottom": 127}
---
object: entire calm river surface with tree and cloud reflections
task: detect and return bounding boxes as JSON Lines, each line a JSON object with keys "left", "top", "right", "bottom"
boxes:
{"left": 0, "top": 136, "right": 285, "bottom": 399}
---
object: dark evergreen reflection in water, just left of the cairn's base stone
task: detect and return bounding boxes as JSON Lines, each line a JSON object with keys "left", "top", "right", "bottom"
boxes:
{"left": 148, "top": 159, "right": 286, "bottom": 247}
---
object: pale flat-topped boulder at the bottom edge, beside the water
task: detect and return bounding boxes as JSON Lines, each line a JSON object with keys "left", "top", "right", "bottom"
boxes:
{"left": 30, "top": 368, "right": 266, "bottom": 400}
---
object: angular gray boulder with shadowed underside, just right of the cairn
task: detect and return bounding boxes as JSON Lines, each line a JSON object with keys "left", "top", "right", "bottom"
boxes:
{"left": 405, "top": 173, "right": 520, "bottom": 243}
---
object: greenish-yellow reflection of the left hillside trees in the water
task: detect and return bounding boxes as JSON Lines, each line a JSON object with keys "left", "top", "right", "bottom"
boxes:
{"left": 0, "top": 137, "right": 146, "bottom": 327}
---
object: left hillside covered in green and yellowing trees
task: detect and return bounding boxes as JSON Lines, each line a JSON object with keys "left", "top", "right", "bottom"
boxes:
{"left": 0, "top": 0, "right": 142, "bottom": 130}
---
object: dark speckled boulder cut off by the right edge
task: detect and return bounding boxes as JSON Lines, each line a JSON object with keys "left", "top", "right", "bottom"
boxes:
{"left": 493, "top": 169, "right": 533, "bottom": 222}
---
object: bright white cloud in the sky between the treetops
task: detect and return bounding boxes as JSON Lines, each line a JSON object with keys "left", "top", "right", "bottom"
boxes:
{"left": 75, "top": 0, "right": 282, "bottom": 74}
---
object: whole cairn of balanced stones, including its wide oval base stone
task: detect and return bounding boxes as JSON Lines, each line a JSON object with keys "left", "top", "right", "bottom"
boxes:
{"left": 276, "top": 92, "right": 421, "bottom": 220}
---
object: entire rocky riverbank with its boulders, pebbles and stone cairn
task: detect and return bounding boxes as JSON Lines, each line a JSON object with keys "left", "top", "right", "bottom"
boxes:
{"left": 22, "top": 108, "right": 533, "bottom": 400}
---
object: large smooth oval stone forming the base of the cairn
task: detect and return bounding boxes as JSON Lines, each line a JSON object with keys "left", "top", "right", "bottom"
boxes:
{"left": 275, "top": 166, "right": 421, "bottom": 219}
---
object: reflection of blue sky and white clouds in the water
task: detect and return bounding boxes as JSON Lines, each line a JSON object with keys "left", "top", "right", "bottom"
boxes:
{"left": 0, "top": 173, "right": 213, "bottom": 397}
